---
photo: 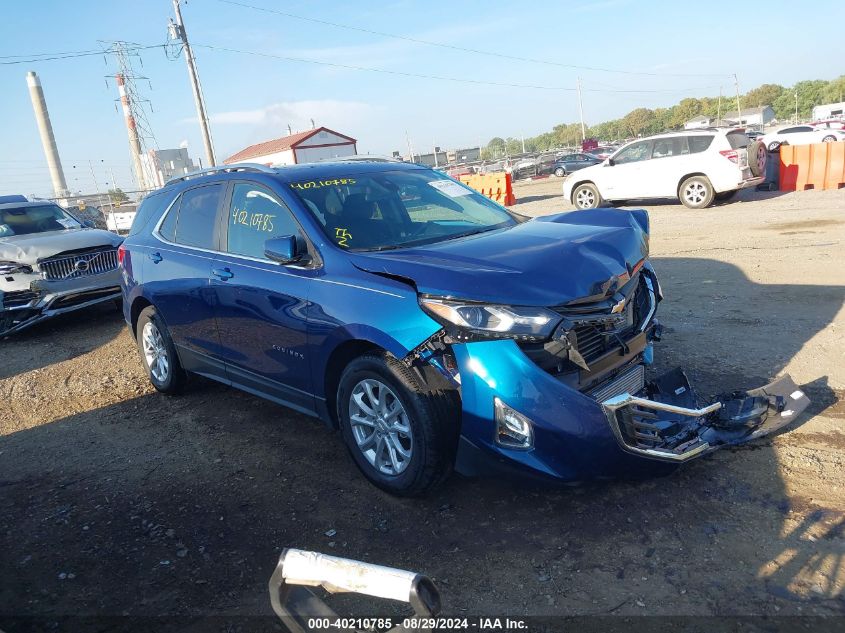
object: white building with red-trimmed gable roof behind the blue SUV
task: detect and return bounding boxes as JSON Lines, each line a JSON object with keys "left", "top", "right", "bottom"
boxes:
{"left": 223, "top": 127, "right": 358, "bottom": 165}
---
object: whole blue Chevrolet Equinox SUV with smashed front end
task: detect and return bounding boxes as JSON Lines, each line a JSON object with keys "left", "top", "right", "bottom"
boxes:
{"left": 118, "top": 160, "right": 807, "bottom": 495}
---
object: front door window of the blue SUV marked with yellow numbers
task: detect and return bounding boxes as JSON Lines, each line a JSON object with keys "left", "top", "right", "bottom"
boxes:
{"left": 226, "top": 183, "right": 300, "bottom": 258}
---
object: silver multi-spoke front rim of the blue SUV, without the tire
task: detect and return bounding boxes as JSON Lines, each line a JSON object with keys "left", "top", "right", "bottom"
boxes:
{"left": 349, "top": 378, "right": 414, "bottom": 475}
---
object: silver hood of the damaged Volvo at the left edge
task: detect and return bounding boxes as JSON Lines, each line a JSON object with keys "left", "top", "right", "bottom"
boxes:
{"left": 0, "top": 229, "right": 123, "bottom": 265}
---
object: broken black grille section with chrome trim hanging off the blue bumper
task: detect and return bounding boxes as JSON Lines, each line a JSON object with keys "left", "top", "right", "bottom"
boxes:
{"left": 601, "top": 369, "right": 810, "bottom": 462}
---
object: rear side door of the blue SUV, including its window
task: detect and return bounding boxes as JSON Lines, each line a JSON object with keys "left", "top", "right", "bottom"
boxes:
{"left": 144, "top": 183, "right": 226, "bottom": 377}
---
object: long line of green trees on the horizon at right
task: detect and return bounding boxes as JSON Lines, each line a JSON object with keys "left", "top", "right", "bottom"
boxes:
{"left": 482, "top": 75, "right": 845, "bottom": 158}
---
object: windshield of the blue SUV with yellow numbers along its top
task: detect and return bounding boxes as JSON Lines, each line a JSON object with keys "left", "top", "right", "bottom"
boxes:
{"left": 289, "top": 169, "right": 517, "bottom": 250}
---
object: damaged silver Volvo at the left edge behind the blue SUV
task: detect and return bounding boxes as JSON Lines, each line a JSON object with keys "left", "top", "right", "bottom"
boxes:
{"left": 0, "top": 202, "right": 123, "bottom": 337}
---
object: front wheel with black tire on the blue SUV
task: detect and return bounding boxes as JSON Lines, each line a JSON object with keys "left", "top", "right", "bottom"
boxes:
{"left": 337, "top": 353, "right": 460, "bottom": 496}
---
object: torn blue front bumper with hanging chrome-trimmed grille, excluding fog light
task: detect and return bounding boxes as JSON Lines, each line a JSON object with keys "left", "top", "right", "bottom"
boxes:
{"left": 452, "top": 340, "right": 809, "bottom": 482}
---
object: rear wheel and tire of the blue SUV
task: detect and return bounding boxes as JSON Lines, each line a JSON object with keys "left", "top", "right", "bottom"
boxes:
{"left": 135, "top": 306, "right": 187, "bottom": 395}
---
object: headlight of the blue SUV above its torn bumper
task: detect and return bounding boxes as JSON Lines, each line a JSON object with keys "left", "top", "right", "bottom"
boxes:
{"left": 420, "top": 297, "right": 561, "bottom": 340}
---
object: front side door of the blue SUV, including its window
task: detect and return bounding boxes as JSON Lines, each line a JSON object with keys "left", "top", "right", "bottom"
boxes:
{"left": 211, "top": 181, "right": 314, "bottom": 412}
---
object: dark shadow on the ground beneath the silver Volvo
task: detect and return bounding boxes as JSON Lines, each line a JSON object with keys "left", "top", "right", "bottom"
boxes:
{"left": 0, "top": 301, "right": 126, "bottom": 379}
